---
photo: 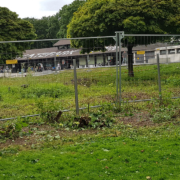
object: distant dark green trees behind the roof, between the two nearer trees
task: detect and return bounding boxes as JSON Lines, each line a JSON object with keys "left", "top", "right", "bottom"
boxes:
{"left": 24, "top": 0, "right": 85, "bottom": 48}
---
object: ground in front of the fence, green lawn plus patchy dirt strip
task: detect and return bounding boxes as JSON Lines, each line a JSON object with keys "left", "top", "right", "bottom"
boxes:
{"left": 0, "top": 99, "right": 180, "bottom": 180}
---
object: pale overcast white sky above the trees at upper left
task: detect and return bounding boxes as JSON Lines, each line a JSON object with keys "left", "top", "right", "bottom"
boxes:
{"left": 0, "top": 0, "right": 73, "bottom": 18}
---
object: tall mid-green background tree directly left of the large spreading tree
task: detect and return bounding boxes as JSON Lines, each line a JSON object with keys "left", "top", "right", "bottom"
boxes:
{"left": 57, "top": 0, "right": 85, "bottom": 38}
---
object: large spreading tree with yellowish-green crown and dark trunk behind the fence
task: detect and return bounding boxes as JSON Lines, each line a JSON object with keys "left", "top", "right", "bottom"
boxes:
{"left": 67, "top": 0, "right": 180, "bottom": 77}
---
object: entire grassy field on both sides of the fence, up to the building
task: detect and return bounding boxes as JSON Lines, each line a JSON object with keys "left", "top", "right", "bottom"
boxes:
{"left": 0, "top": 64, "right": 180, "bottom": 180}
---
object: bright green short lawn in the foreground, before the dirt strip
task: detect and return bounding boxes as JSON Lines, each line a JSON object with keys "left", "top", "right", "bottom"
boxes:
{"left": 0, "top": 126, "right": 180, "bottom": 180}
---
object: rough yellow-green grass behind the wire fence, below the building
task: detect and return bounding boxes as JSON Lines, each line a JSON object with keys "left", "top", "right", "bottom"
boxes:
{"left": 0, "top": 63, "right": 180, "bottom": 118}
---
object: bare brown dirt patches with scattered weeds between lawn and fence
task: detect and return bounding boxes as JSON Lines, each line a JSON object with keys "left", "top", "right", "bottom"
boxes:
{"left": 0, "top": 111, "right": 160, "bottom": 149}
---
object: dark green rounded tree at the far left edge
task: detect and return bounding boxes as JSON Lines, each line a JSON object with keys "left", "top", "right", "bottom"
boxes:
{"left": 0, "top": 7, "right": 36, "bottom": 63}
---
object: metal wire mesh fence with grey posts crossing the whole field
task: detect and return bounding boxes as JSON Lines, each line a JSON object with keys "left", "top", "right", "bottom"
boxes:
{"left": 0, "top": 32, "right": 180, "bottom": 120}
